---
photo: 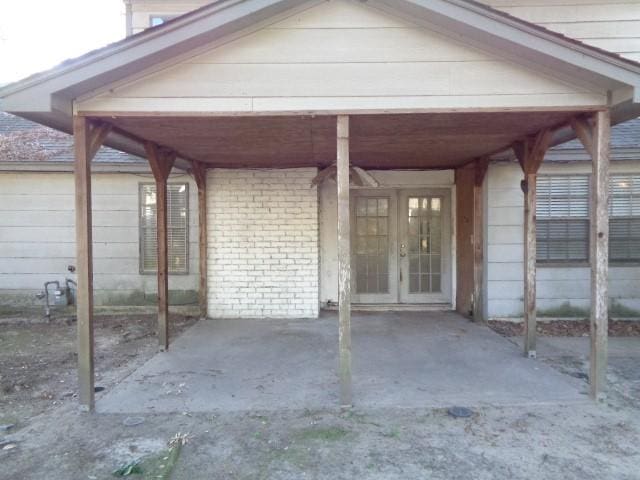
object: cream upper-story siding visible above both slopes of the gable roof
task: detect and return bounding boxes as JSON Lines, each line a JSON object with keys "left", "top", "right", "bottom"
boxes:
{"left": 125, "top": 0, "right": 640, "bottom": 61}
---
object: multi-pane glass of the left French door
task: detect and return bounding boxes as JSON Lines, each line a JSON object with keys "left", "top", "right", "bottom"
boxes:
{"left": 354, "top": 197, "right": 389, "bottom": 293}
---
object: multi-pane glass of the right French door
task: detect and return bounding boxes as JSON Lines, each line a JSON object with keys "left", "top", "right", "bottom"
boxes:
{"left": 407, "top": 196, "right": 442, "bottom": 293}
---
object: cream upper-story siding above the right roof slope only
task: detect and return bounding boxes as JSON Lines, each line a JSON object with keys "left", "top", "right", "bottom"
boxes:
{"left": 480, "top": 0, "right": 640, "bottom": 61}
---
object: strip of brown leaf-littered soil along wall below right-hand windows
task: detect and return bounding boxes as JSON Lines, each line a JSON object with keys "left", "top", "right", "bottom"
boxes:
{"left": 487, "top": 320, "right": 640, "bottom": 337}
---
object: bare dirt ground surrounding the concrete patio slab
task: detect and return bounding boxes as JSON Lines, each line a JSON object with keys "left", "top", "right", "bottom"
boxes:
{"left": 0, "top": 315, "right": 640, "bottom": 480}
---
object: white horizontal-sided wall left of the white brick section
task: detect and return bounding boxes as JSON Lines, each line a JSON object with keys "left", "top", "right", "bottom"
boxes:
{"left": 0, "top": 173, "right": 198, "bottom": 305}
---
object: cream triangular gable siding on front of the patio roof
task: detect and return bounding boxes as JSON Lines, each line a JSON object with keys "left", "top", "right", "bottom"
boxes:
{"left": 79, "top": 1, "right": 604, "bottom": 111}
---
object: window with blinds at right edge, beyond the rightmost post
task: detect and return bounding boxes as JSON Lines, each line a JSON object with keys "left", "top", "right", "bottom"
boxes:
{"left": 609, "top": 175, "right": 640, "bottom": 262}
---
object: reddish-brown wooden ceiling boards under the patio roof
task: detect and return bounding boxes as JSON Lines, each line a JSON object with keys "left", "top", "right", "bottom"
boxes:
{"left": 104, "top": 112, "right": 576, "bottom": 169}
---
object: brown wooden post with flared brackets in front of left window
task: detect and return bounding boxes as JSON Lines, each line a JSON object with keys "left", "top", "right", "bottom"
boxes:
{"left": 145, "top": 142, "right": 175, "bottom": 351}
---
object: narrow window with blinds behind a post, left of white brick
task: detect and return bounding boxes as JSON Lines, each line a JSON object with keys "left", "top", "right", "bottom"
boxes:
{"left": 140, "top": 183, "right": 189, "bottom": 273}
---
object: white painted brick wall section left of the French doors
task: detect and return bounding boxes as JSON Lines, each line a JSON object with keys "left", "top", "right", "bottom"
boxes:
{"left": 207, "top": 168, "right": 319, "bottom": 318}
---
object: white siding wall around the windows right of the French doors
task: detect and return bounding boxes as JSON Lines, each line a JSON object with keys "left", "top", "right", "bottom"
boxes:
{"left": 485, "top": 162, "right": 640, "bottom": 319}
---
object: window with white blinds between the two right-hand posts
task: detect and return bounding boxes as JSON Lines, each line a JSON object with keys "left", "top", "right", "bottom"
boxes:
{"left": 536, "top": 175, "right": 589, "bottom": 262}
